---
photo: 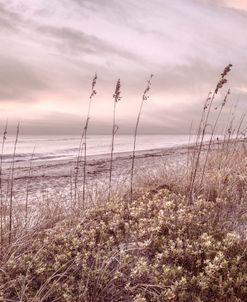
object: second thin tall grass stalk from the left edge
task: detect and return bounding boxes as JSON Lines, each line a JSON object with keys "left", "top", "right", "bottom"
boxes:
{"left": 9, "top": 123, "right": 20, "bottom": 245}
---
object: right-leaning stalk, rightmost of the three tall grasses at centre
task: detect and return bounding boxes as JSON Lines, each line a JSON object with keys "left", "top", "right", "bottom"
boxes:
{"left": 130, "top": 74, "right": 153, "bottom": 202}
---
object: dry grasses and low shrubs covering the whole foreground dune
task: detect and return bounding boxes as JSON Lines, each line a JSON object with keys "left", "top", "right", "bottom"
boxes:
{"left": 0, "top": 65, "right": 247, "bottom": 302}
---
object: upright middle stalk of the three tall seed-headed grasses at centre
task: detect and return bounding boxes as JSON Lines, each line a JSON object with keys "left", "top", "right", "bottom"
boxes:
{"left": 108, "top": 79, "right": 121, "bottom": 201}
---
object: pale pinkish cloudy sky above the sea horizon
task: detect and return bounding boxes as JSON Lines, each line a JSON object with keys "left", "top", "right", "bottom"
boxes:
{"left": 0, "top": 0, "right": 247, "bottom": 134}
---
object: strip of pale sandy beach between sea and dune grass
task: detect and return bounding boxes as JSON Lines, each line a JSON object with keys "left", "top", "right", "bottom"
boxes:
{"left": 2, "top": 145, "right": 191, "bottom": 204}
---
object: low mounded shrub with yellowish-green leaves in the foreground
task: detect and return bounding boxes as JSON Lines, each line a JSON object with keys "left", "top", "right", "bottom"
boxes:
{"left": 0, "top": 189, "right": 247, "bottom": 302}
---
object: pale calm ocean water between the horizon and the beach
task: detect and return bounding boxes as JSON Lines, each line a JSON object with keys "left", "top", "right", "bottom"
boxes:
{"left": 0, "top": 135, "right": 199, "bottom": 163}
